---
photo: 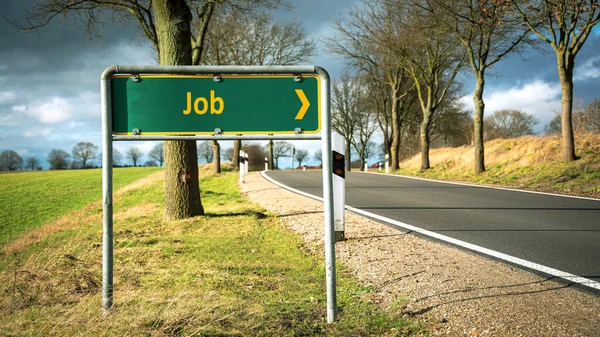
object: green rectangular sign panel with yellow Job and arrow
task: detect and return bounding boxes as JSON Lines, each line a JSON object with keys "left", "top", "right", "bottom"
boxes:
{"left": 112, "top": 75, "right": 321, "bottom": 135}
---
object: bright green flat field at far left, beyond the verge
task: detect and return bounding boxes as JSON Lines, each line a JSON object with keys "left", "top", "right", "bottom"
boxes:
{"left": 0, "top": 168, "right": 161, "bottom": 246}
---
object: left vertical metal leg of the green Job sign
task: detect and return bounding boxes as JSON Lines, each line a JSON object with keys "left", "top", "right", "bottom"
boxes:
{"left": 100, "top": 68, "right": 114, "bottom": 313}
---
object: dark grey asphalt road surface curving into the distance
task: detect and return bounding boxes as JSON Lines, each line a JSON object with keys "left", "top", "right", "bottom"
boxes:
{"left": 267, "top": 171, "right": 600, "bottom": 282}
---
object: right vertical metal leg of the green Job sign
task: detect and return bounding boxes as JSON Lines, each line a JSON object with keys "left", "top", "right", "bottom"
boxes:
{"left": 315, "top": 67, "right": 337, "bottom": 323}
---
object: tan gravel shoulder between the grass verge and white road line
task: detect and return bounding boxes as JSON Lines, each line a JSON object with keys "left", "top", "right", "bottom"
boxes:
{"left": 240, "top": 173, "right": 600, "bottom": 336}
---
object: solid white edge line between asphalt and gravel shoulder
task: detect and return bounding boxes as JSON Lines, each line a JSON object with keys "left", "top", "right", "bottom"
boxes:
{"left": 261, "top": 172, "right": 600, "bottom": 290}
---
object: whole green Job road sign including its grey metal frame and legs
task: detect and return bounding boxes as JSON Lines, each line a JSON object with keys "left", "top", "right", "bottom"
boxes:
{"left": 100, "top": 66, "right": 337, "bottom": 323}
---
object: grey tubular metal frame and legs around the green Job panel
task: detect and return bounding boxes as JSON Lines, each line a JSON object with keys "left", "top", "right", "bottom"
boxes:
{"left": 100, "top": 66, "right": 337, "bottom": 323}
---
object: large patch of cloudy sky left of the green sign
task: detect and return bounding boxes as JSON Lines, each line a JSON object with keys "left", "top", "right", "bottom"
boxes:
{"left": 0, "top": 1, "right": 155, "bottom": 167}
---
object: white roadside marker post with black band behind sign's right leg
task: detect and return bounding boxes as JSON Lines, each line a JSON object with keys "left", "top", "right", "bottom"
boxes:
{"left": 331, "top": 132, "right": 346, "bottom": 241}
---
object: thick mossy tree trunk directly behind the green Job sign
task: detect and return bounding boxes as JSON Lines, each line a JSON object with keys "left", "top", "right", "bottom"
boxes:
{"left": 152, "top": 0, "right": 204, "bottom": 221}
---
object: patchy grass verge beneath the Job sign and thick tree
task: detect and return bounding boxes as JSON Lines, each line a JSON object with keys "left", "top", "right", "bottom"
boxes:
{"left": 0, "top": 173, "right": 426, "bottom": 336}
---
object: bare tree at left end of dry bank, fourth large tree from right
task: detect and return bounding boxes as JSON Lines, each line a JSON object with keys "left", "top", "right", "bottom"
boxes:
{"left": 326, "top": 0, "right": 414, "bottom": 170}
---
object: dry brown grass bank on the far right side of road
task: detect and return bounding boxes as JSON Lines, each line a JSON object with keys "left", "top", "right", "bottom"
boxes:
{"left": 398, "top": 134, "right": 600, "bottom": 197}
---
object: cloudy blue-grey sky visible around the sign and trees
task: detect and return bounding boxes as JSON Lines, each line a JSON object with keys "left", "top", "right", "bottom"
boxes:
{"left": 0, "top": 0, "right": 600, "bottom": 168}
